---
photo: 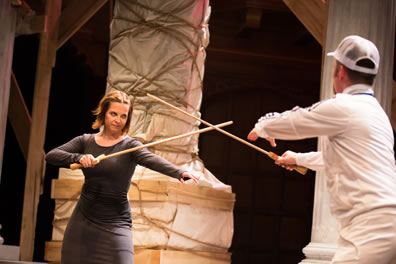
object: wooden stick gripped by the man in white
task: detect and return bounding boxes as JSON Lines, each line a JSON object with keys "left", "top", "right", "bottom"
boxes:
{"left": 147, "top": 93, "right": 308, "bottom": 175}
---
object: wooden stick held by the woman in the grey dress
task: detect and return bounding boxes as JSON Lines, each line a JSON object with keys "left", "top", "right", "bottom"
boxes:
{"left": 70, "top": 121, "right": 232, "bottom": 170}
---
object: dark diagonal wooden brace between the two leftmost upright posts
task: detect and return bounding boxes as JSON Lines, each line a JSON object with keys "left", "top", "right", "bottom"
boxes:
{"left": 8, "top": 73, "right": 32, "bottom": 160}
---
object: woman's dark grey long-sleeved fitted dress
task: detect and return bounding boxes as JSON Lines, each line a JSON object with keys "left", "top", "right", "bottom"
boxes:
{"left": 46, "top": 134, "right": 184, "bottom": 264}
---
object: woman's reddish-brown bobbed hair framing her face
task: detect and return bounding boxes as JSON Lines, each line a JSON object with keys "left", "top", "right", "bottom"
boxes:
{"left": 92, "top": 91, "right": 133, "bottom": 133}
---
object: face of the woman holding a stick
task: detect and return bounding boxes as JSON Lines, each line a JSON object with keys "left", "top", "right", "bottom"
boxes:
{"left": 104, "top": 102, "right": 129, "bottom": 133}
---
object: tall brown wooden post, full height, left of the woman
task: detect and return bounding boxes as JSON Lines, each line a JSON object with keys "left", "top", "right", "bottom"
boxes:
{"left": 20, "top": 0, "right": 62, "bottom": 261}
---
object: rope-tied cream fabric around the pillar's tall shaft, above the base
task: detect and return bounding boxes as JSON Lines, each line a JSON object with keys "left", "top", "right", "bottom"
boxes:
{"left": 108, "top": 0, "right": 231, "bottom": 192}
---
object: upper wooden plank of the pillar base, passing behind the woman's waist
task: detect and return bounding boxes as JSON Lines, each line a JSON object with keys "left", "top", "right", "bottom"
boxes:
{"left": 51, "top": 179, "right": 235, "bottom": 211}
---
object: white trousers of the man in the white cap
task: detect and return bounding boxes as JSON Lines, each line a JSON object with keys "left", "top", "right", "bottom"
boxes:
{"left": 332, "top": 209, "right": 396, "bottom": 264}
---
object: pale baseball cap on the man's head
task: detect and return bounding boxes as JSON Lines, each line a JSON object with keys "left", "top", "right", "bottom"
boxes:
{"left": 327, "top": 35, "right": 380, "bottom": 75}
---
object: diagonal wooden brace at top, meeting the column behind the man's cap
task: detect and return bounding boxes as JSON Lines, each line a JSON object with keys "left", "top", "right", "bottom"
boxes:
{"left": 283, "top": 0, "right": 328, "bottom": 46}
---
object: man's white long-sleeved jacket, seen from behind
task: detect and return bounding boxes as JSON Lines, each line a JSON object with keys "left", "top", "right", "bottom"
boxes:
{"left": 255, "top": 84, "right": 396, "bottom": 223}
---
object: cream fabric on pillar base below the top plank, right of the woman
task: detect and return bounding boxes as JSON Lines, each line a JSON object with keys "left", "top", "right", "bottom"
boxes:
{"left": 131, "top": 202, "right": 233, "bottom": 252}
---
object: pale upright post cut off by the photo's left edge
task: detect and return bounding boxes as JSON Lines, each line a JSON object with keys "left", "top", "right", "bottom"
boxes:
{"left": 0, "top": 1, "right": 16, "bottom": 184}
